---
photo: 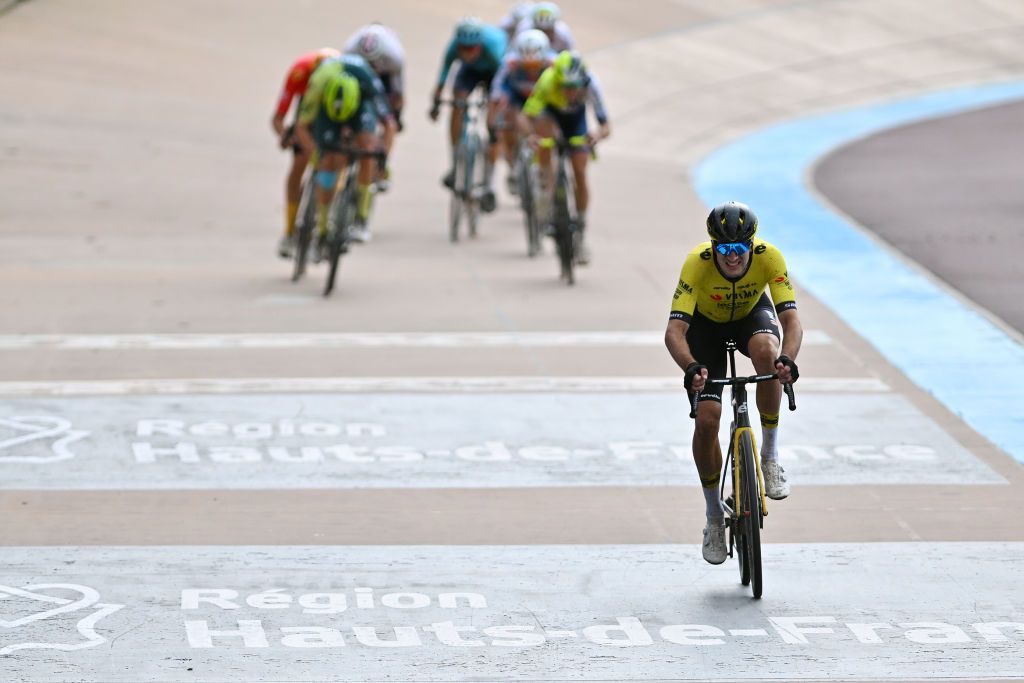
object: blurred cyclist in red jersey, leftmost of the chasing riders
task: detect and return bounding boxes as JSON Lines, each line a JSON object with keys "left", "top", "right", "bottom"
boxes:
{"left": 270, "top": 47, "right": 341, "bottom": 258}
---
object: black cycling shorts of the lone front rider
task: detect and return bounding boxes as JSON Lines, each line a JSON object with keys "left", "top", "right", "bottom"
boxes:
{"left": 686, "top": 294, "right": 782, "bottom": 404}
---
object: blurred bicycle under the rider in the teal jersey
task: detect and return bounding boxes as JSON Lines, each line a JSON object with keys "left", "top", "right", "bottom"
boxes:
{"left": 441, "top": 96, "right": 489, "bottom": 242}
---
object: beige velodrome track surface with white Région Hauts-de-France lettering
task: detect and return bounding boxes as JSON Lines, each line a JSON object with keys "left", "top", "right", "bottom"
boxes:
{"left": 0, "top": 0, "right": 1024, "bottom": 681}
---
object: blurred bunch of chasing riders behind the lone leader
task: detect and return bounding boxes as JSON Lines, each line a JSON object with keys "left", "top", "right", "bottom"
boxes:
{"left": 272, "top": 2, "right": 610, "bottom": 264}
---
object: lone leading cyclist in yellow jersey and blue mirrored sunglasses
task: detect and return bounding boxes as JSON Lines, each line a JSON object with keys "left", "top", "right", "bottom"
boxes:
{"left": 665, "top": 202, "right": 804, "bottom": 564}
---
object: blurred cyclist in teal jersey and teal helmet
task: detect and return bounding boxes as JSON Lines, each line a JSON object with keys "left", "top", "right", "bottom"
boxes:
{"left": 430, "top": 17, "right": 508, "bottom": 211}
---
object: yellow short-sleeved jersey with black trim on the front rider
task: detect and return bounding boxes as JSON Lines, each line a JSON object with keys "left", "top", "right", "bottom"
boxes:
{"left": 671, "top": 239, "right": 797, "bottom": 323}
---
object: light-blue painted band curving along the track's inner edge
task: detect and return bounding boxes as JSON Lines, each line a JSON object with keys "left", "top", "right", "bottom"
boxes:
{"left": 694, "top": 81, "right": 1024, "bottom": 462}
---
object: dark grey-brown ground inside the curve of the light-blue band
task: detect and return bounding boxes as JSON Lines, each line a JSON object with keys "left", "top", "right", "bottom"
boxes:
{"left": 814, "top": 102, "right": 1024, "bottom": 333}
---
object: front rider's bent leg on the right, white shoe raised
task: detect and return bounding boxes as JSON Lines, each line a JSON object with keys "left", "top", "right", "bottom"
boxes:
{"left": 736, "top": 294, "right": 790, "bottom": 500}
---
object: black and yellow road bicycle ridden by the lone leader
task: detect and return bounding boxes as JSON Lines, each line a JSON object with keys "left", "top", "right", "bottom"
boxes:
{"left": 690, "top": 340, "right": 797, "bottom": 598}
